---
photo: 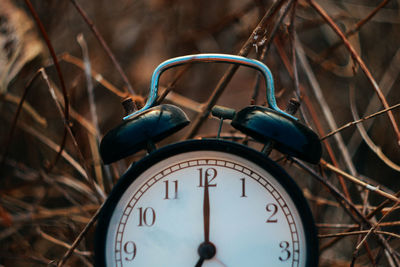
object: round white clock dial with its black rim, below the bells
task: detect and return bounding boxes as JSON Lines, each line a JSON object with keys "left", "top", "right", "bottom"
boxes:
{"left": 96, "top": 140, "right": 318, "bottom": 267}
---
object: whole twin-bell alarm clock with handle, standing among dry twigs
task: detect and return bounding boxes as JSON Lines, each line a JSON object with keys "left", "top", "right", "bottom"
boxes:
{"left": 95, "top": 54, "right": 321, "bottom": 267}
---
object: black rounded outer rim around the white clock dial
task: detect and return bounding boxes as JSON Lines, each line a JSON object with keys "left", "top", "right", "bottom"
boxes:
{"left": 94, "top": 139, "right": 319, "bottom": 267}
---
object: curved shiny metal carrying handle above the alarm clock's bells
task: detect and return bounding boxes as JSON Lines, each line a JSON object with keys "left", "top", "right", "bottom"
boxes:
{"left": 124, "top": 54, "right": 298, "bottom": 121}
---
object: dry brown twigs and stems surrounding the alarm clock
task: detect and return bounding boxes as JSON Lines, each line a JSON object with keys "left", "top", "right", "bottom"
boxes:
{"left": 0, "top": 0, "right": 400, "bottom": 266}
